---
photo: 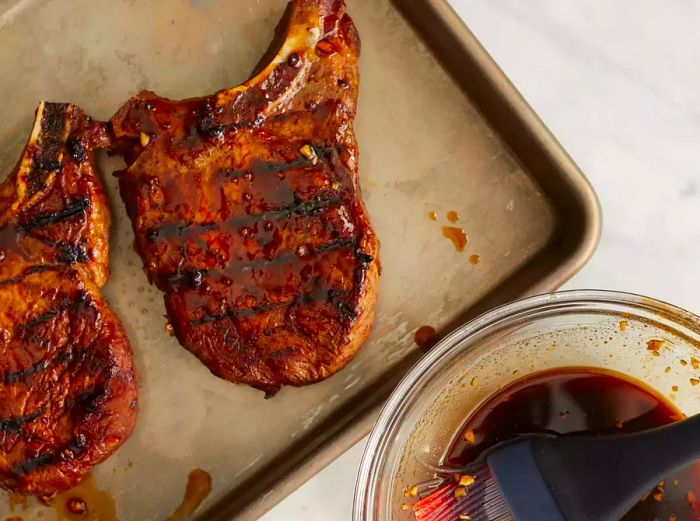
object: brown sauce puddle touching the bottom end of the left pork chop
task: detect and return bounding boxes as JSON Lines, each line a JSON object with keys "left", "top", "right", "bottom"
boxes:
{"left": 46, "top": 475, "right": 119, "bottom": 521}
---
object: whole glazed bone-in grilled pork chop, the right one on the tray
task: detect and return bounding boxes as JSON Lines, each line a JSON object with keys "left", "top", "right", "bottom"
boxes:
{"left": 111, "top": 0, "right": 378, "bottom": 394}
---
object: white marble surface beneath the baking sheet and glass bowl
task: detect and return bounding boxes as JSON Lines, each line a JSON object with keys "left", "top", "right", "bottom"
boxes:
{"left": 264, "top": 0, "right": 700, "bottom": 521}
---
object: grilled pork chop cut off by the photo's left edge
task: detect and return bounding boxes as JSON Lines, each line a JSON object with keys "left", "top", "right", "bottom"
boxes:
{"left": 0, "top": 103, "right": 136, "bottom": 495}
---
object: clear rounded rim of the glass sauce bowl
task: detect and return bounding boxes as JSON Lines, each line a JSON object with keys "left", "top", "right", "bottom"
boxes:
{"left": 352, "top": 290, "right": 700, "bottom": 521}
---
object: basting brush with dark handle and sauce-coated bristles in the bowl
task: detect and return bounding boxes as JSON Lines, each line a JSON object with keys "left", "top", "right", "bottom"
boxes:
{"left": 413, "top": 415, "right": 700, "bottom": 521}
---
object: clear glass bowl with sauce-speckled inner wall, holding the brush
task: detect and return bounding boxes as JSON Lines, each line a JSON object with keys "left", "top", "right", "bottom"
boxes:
{"left": 353, "top": 291, "right": 700, "bottom": 521}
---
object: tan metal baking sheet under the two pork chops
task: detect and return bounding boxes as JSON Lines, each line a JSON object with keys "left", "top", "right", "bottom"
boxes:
{"left": 0, "top": 0, "right": 600, "bottom": 521}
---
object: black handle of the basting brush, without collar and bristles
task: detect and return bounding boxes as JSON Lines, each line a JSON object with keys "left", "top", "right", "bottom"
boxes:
{"left": 531, "top": 415, "right": 700, "bottom": 521}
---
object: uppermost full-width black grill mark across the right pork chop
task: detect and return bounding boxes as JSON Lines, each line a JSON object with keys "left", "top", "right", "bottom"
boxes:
{"left": 146, "top": 196, "right": 342, "bottom": 243}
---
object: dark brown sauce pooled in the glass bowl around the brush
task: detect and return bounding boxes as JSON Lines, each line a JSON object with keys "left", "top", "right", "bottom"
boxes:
{"left": 446, "top": 368, "right": 700, "bottom": 521}
